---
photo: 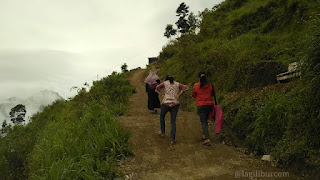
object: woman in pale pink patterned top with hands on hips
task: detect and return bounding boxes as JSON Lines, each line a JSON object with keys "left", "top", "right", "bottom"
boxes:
{"left": 156, "top": 75, "right": 189, "bottom": 145}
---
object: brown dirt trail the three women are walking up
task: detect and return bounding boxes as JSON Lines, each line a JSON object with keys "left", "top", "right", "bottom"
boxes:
{"left": 118, "top": 69, "right": 298, "bottom": 180}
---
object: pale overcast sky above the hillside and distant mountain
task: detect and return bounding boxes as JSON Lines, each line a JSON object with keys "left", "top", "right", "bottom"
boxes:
{"left": 0, "top": 0, "right": 222, "bottom": 103}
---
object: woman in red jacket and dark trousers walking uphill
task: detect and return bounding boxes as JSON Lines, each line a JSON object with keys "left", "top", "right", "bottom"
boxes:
{"left": 192, "top": 71, "right": 215, "bottom": 145}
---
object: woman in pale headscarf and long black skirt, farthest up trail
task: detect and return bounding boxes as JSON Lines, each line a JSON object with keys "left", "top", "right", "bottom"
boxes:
{"left": 144, "top": 70, "right": 160, "bottom": 114}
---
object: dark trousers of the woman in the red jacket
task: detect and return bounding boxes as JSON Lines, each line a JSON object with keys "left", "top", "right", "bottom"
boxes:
{"left": 198, "top": 105, "right": 213, "bottom": 139}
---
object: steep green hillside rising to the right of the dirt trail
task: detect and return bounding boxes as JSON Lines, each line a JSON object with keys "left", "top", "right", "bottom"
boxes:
{"left": 154, "top": 0, "right": 320, "bottom": 177}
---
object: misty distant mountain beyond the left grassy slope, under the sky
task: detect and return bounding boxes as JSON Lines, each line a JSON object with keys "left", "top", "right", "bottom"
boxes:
{"left": 0, "top": 90, "right": 63, "bottom": 125}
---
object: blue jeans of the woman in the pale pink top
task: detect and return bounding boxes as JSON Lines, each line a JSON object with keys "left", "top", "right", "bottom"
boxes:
{"left": 160, "top": 104, "right": 180, "bottom": 141}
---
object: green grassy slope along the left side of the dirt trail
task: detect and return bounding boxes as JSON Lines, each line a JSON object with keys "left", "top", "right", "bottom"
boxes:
{"left": 0, "top": 72, "right": 135, "bottom": 180}
